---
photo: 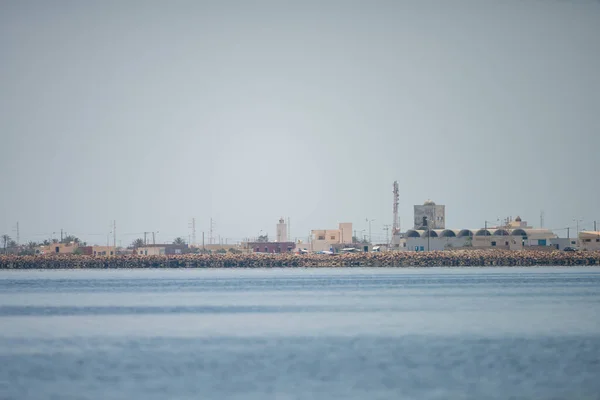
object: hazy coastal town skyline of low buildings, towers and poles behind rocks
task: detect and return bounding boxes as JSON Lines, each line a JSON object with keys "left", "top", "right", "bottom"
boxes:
{"left": 3, "top": 182, "right": 600, "bottom": 256}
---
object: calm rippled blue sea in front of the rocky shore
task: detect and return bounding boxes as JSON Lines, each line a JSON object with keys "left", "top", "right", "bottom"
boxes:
{"left": 0, "top": 268, "right": 600, "bottom": 400}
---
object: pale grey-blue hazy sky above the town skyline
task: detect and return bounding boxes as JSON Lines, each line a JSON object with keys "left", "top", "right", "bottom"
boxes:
{"left": 0, "top": 0, "right": 600, "bottom": 246}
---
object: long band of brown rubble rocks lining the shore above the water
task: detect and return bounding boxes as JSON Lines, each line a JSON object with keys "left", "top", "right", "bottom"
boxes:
{"left": 0, "top": 250, "right": 600, "bottom": 269}
